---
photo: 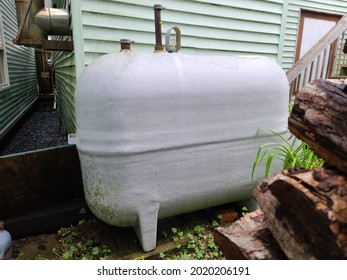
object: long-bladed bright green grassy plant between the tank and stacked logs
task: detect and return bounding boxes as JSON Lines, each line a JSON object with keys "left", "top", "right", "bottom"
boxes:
{"left": 252, "top": 129, "right": 324, "bottom": 180}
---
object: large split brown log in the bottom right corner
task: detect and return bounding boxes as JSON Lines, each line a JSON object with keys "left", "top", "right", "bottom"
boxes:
{"left": 254, "top": 169, "right": 347, "bottom": 259}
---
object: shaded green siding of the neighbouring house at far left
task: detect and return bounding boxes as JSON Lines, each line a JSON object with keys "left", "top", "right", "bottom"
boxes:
{"left": 0, "top": 1, "right": 37, "bottom": 139}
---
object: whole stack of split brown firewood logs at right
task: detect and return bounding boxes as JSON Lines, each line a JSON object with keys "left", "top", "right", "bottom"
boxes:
{"left": 215, "top": 80, "right": 347, "bottom": 260}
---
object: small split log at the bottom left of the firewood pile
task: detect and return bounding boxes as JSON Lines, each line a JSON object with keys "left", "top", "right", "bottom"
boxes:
{"left": 214, "top": 209, "right": 287, "bottom": 260}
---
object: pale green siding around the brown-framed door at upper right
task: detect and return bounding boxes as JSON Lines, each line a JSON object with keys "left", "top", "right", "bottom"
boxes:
{"left": 281, "top": 0, "right": 347, "bottom": 70}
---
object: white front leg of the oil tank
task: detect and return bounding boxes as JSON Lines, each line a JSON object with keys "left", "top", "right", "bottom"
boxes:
{"left": 134, "top": 204, "right": 159, "bottom": 252}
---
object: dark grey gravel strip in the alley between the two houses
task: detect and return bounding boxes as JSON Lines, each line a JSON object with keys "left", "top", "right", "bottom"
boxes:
{"left": 0, "top": 107, "right": 67, "bottom": 156}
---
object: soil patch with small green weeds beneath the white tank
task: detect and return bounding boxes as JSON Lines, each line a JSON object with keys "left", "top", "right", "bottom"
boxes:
{"left": 12, "top": 205, "right": 245, "bottom": 260}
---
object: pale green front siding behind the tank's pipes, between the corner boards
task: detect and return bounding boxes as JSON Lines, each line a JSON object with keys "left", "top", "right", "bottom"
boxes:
{"left": 81, "top": 0, "right": 283, "bottom": 65}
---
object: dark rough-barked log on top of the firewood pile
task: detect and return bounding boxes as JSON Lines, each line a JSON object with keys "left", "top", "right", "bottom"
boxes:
{"left": 288, "top": 80, "right": 347, "bottom": 173}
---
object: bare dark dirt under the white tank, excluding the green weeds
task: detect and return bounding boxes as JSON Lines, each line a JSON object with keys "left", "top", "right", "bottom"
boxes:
{"left": 8, "top": 204, "right": 245, "bottom": 260}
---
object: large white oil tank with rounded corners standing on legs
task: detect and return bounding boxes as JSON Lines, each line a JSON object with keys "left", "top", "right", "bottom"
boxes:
{"left": 75, "top": 48, "right": 289, "bottom": 251}
